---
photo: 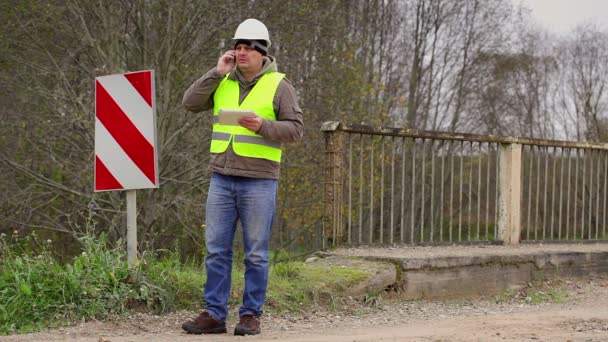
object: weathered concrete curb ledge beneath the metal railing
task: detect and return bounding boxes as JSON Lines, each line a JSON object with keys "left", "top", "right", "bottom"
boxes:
{"left": 322, "top": 251, "right": 608, "bottom": 299}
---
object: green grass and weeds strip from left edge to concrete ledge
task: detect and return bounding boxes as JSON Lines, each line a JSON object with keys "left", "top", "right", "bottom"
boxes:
{"left": 0, "top": 235, "right": 367, "bottom": 335}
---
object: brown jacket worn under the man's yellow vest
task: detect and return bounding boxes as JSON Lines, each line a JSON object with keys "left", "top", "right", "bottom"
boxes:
{"left": 182, "top": 56, "right": 304, "bottom": 179}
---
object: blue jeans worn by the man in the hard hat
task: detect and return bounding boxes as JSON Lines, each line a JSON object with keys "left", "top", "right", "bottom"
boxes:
{"left": 205, "top": 173, "right": 278, "bottom": 321}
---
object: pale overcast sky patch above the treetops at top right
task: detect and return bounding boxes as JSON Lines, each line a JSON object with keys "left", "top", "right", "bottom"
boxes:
{"left": 514, "top": 0, "right": 608, "bottom": 34}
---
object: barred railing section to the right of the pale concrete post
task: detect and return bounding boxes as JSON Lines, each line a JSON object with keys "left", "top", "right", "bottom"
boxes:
{"left": 521, "top": 145, "right": 608, "bottom": 241}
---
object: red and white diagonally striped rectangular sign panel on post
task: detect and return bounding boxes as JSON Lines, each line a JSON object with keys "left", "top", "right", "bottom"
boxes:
{"left": 95, "top": 70, "right": 158, "bottom": 191}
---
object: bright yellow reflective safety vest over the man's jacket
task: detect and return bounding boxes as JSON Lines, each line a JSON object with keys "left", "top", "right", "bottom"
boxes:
{"left": 210, "top": 72, "right": 285, "bottom": 163}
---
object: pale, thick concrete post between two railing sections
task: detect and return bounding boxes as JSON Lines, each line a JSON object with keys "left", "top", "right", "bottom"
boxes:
{"left": 498, "top": 144, "right": 522, "bottom": 245}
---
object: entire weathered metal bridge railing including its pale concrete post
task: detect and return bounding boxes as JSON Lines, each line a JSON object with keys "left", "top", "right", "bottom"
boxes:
{"left": 322, "top": 122, "right": 608, "bottom": 245}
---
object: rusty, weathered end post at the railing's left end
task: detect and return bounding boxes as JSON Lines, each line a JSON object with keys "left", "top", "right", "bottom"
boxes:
{"left": 321, "top": 121, "right": 344, "bottom": 249}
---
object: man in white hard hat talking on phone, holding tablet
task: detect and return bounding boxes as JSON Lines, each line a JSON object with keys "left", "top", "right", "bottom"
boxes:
{"left": 182, "top": 19, "right": 303, "bottom": 335}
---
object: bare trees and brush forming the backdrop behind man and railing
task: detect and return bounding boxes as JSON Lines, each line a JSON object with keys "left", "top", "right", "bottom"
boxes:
{"left": 0, "top": 0, "right": 608, "bottom": 254}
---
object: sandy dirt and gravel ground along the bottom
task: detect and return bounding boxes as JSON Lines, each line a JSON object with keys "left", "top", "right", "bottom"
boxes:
{"left": 0, "top": 276, "right": 608, "bottom": 342}
